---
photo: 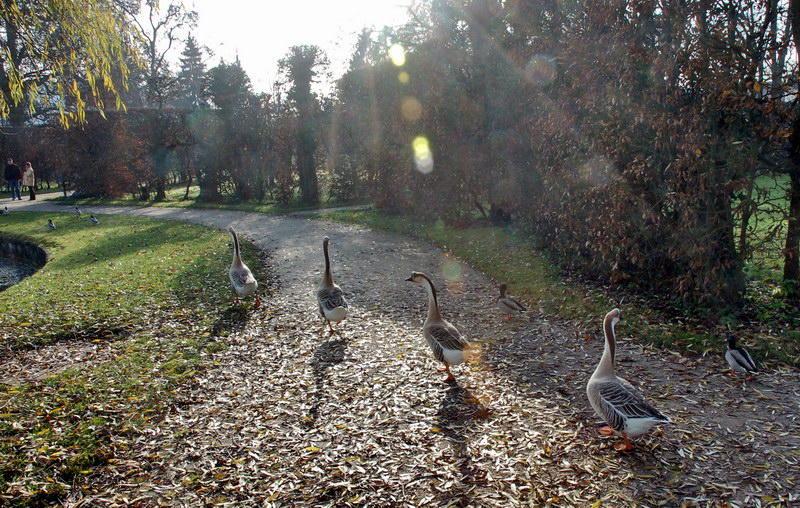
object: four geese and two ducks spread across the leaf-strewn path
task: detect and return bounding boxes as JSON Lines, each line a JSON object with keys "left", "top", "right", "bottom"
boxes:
{"left": 223, "top": 228, "right": 756, "bottom": 451}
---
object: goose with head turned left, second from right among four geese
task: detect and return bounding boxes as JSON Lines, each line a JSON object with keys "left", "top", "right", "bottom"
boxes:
{"left": 406, "top": 272, "right": 469, "bottom": 382}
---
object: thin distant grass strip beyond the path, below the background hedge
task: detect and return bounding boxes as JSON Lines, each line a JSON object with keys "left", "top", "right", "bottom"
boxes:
{"left": 51, "top": 185, "right": 370, "bottom": 214}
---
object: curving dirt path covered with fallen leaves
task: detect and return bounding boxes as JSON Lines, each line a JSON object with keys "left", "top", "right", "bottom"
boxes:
{"left": 6, "top": 197, "right": 800, "bottom": 506}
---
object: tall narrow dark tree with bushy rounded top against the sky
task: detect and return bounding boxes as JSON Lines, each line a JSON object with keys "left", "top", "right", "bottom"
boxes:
{"left": 278, "top": 46, "right": 328, "bottom": 204}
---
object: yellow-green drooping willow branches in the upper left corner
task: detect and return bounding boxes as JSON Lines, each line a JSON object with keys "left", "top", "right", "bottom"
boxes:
{"left": 0, "top": 0, "right": 132, "bottom": 126}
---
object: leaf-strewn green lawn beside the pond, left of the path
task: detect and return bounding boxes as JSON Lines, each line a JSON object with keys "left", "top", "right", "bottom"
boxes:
{"left": 0, "top": 212, "right": 265, "bottom": 505}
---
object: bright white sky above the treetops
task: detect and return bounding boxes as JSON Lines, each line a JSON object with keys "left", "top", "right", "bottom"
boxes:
{"left": 187, "top": 0, "right": 412, "bottom": 92}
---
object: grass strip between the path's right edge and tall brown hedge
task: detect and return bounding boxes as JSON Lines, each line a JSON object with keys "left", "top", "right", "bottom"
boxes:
{"left": 320, "top": 211, "right": 800, "bottom": 367}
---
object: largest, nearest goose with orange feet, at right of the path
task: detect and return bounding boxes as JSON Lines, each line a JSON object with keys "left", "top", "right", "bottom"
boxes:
{"left": 586, "top": 309, "right": 670, "bottom": 451}
